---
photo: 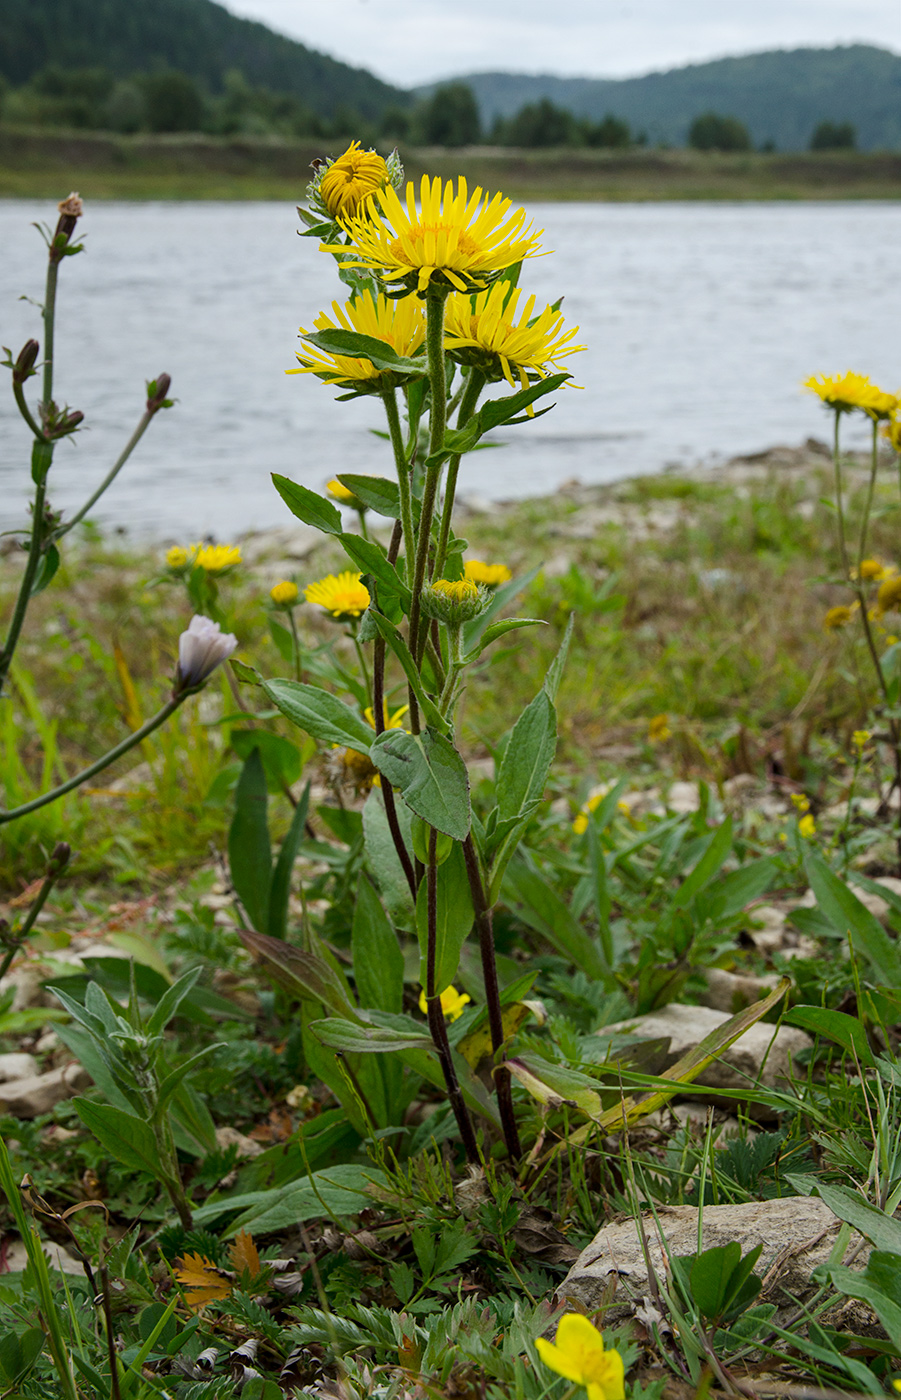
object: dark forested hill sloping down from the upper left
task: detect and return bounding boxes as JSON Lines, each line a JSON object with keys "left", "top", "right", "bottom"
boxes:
{"left": 0, "top": 0, "right": 407, "bottom": 118}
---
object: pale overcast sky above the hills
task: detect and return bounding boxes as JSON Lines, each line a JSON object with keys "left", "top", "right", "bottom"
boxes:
{"left": 219, "top": 0, "right": 901, "bottom": 87}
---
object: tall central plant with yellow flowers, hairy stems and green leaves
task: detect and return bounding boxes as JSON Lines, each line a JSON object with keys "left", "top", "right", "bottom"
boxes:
{"left": 248, "top": 143, "right": 582, "bottom": 1161}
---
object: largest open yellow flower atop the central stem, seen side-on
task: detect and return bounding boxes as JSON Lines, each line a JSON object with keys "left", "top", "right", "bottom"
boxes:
{"left": 320, "top": 175, "right": 539, "bottom": 293}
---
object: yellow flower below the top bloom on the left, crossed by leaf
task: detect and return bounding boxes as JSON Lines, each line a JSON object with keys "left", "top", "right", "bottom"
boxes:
{"left": 285, "top": 290, "right": 425, "bottom": 392}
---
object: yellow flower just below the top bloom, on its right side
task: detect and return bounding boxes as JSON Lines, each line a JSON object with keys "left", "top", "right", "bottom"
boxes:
{"left": 445, "top": 281, "right": 585, "bottom": 389}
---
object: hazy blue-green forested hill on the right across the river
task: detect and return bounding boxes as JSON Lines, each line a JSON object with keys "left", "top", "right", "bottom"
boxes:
{"left": 436, "top": 43, "right": 901, "bottom": 150}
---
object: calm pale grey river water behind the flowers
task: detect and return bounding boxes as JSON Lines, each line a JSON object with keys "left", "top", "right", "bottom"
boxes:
{"left": 0, "top": 200, "right": 901, "bottom": 540}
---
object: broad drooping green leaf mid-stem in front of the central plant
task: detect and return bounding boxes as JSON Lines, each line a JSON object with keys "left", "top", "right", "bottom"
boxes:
{"left": 369, "top": 729, "right": 471, "bottom": 841}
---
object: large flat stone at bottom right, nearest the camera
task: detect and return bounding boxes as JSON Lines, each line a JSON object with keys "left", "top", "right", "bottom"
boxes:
{"left": 557, "top": 1196, "right": 870, "bottom": 1327}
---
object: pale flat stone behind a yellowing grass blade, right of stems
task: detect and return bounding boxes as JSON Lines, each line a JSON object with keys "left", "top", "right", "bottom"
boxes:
{"left": 597, "top": 1002, "right": 813, "bottom": 1092}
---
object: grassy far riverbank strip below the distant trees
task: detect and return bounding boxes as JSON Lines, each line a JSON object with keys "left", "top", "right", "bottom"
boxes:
{"left": 0, "top": 126, "right": 901, "bottom": 203}
